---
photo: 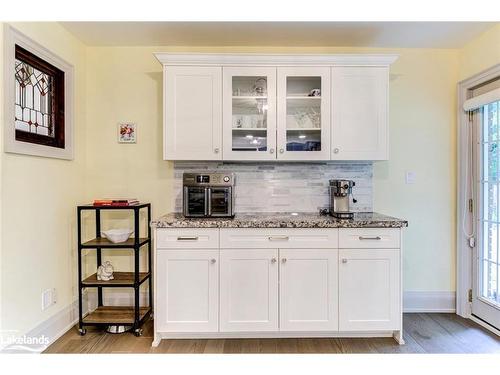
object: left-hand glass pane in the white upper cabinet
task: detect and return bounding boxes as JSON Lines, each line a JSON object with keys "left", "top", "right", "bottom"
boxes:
{"left": 232, "top": 76, "right": 268, "bottom": 152}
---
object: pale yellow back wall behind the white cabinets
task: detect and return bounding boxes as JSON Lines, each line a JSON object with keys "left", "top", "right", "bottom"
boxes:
{"left": 83, "top": 47, "right": 458, "bottom": 291}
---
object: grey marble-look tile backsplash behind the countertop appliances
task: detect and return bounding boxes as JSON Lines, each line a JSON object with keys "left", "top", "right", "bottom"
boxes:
{"left": 174, "top": 161, "right": 373, "bottom": 212}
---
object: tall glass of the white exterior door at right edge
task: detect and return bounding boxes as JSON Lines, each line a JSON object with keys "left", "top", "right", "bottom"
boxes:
{"left": 479, "top": 102, "right": 500, "bottom": 305}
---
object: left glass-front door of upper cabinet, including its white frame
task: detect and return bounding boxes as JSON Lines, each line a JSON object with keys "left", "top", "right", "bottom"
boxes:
{"left": 223, "top": 67, "right": 276, "bottom": 160}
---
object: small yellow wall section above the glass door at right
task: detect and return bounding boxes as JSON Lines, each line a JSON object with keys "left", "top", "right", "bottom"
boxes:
{"left": 459, "top": 24, "right": 500, "bottom": 81}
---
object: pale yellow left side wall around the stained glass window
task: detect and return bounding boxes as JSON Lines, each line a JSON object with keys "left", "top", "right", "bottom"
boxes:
{"left": 0, "top": 23, "right": 86, "bottom": 334}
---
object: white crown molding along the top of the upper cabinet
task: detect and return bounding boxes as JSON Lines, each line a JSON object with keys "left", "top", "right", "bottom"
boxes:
{"left": 154, "top": 52, "right": 399, "bottom": 66}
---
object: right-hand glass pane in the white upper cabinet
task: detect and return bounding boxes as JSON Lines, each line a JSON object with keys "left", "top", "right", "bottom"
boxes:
{"left": 286, "top": 77, "right": 321, "bottom": 151}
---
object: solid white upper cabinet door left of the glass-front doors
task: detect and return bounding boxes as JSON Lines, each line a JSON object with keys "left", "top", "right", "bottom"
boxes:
{"left": 163, "top": 66, "right": 222, "bottom": 160}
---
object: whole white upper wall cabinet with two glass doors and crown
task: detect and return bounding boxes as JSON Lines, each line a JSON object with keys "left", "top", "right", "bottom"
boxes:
{"left": 156, "top": 53, "right": 397, "bottom": 161}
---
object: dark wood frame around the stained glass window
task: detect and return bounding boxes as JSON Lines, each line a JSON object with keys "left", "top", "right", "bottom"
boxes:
{"left": 15, "top": 44, "right": 65, "bottom": 148}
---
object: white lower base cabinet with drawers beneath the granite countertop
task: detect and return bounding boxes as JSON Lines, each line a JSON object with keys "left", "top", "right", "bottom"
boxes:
{"left": 155, "top": 228, "right": 402, "bottom": 344}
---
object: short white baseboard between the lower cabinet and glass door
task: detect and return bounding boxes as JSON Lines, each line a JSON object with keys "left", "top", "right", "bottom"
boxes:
{"left": 403, "top": 291, "right": 456, "bottom": 313}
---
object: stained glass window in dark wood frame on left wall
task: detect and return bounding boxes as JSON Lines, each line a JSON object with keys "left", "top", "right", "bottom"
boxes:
{"left": 15, "top": 45, "right": 64, "bottom": 148}
